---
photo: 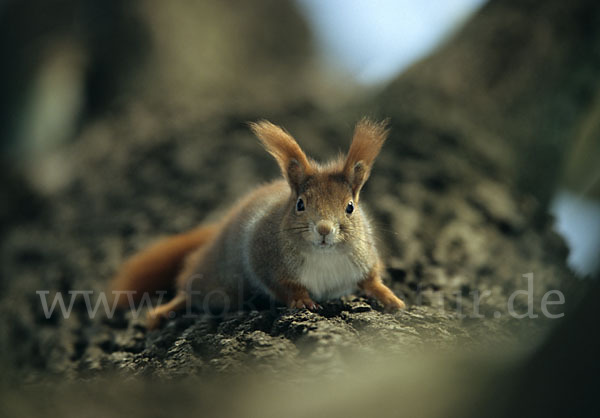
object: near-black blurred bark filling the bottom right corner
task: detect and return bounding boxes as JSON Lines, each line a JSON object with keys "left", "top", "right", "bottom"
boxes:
{"left": 482, "top": 278, "right": 600, "bottom": 417}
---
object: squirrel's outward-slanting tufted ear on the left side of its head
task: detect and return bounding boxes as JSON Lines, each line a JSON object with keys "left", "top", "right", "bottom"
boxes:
{"left": 250, "top": 120, "right": 314, "bottom": 191}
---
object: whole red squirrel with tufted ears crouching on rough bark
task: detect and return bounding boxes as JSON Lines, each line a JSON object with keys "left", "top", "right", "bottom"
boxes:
{"left": 111, "top": 119, "right": 405, "bottom": 328}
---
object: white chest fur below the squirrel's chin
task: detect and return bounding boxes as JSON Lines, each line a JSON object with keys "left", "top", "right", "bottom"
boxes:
{"left": 299, "top": 249, "right": 366, "bottom": 301}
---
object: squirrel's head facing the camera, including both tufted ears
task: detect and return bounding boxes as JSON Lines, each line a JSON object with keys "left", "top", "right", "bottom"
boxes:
{"left": 250, "top": 118, "right": 388, "bottom": 248}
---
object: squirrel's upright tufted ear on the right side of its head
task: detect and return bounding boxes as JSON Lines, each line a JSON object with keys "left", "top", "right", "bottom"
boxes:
{"left": 343, "top": 118, "right": 388, "bottom": 198}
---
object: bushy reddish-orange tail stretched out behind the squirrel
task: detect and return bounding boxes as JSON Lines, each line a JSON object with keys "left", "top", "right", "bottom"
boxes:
{"left": 109, "top": 225, "right": 217, "bottom": 307}
